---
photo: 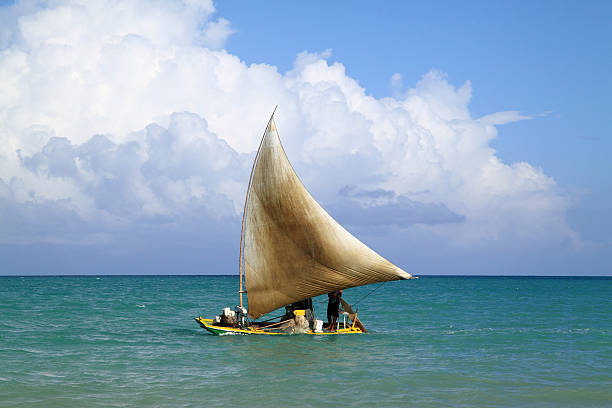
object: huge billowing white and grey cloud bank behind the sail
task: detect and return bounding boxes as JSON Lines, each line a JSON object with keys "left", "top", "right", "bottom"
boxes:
{"left": 0, "top": 0, "right": 580, "bottom": 270}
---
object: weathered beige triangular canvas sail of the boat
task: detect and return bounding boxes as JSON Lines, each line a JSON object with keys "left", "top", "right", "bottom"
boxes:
{"left": 243, "top": 118, "right": 411, "bottom": 318}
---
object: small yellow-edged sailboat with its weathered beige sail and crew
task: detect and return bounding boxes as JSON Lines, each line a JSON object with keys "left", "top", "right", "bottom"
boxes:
{"left": 195, "top": 108, "right": 413, "bottom": 335}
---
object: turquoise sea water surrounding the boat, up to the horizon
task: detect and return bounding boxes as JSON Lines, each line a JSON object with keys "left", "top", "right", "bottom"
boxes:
{"left": 0, "top": 276, "right": 612, "bottom": 407}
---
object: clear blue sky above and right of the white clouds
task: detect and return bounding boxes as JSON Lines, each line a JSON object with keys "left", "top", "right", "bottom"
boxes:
{"left": 217, "top": 1, "right": 612, "bottom": 241}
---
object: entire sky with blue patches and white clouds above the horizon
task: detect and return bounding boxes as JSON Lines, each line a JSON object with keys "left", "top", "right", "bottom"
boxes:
{"left": 0, "top": 0, "right": 612, "bottom": 275}
